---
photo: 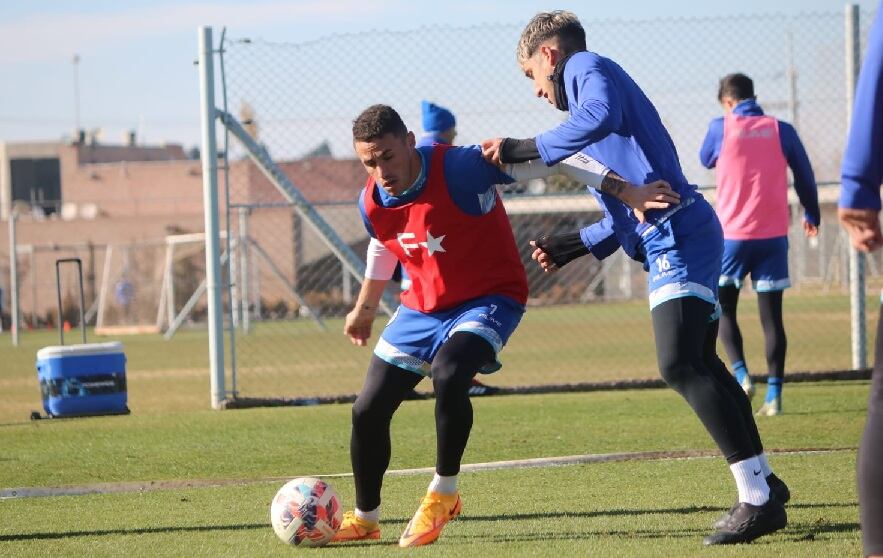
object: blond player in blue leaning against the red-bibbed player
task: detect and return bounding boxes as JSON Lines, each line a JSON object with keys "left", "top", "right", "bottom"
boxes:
{"left": 483, "top": 11, "right": 787, "bottom": 545}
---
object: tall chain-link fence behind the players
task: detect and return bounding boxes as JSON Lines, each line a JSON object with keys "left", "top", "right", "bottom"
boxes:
{"left": 199, "top": 6, "right": 883, "bottom": 404}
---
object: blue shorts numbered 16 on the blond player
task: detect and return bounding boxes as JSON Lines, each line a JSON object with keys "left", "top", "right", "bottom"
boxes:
{"left": 642, "top": 195, "right": 723, "bottom": 310}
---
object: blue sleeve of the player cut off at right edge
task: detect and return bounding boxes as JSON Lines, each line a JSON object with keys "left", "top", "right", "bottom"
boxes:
{"left": 839, "top": 6, "right": 883, "bottom": 211}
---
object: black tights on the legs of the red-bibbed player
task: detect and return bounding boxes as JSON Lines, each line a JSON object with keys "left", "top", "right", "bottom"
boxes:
{"left": 350, "top": 333, "right": 496, "bottom": 511}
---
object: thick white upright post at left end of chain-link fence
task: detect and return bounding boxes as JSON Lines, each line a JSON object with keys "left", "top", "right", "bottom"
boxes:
{"left": 199, "top": 26, "right": 226, "bottom": 409}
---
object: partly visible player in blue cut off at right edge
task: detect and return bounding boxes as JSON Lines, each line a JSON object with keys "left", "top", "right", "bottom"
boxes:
{"left": 840, "top": 3, "right": 883, "bottom": 556}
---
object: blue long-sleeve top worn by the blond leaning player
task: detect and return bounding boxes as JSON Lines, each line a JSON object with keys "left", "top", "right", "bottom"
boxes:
{"left": 536, "top": 51, "right": 698, "bottom": 259}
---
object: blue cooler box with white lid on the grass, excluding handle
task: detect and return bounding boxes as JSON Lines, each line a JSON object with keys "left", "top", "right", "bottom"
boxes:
{"left": 37, "top": 342, "right": 129, "bottom": 417}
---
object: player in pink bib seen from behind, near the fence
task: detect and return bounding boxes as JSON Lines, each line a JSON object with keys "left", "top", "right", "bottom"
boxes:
{"left": 699, "top": 73, "right": 821, "bottom": 416}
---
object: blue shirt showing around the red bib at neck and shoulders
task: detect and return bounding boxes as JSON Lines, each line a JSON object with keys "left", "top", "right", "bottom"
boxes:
{"left": 359, "top": 145, "right": 513, "bottom": 238}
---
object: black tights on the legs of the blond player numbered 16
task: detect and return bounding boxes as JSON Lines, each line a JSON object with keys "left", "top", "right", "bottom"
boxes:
{"left": 652, "top": 297, "right": 763, "bottom": 464}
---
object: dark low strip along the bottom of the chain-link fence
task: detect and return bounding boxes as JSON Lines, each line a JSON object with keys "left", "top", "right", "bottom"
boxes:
{"left": 221, "top": 368, "right": 871, "bottom": 409}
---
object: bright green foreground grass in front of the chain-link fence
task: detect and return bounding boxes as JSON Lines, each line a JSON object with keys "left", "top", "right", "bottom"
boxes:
{"left": 0, "top": 382, "right": 868, "bottom": 556}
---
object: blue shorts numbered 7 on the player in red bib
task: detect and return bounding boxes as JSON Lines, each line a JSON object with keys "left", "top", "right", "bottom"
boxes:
{"left": 374, "top": 295, "right": 524, "bottom": 376}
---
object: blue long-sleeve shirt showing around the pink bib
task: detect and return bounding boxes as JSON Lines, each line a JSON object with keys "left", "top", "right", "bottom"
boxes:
{"left": 699, "top": 99, "right": 821, "bottom": 226}
